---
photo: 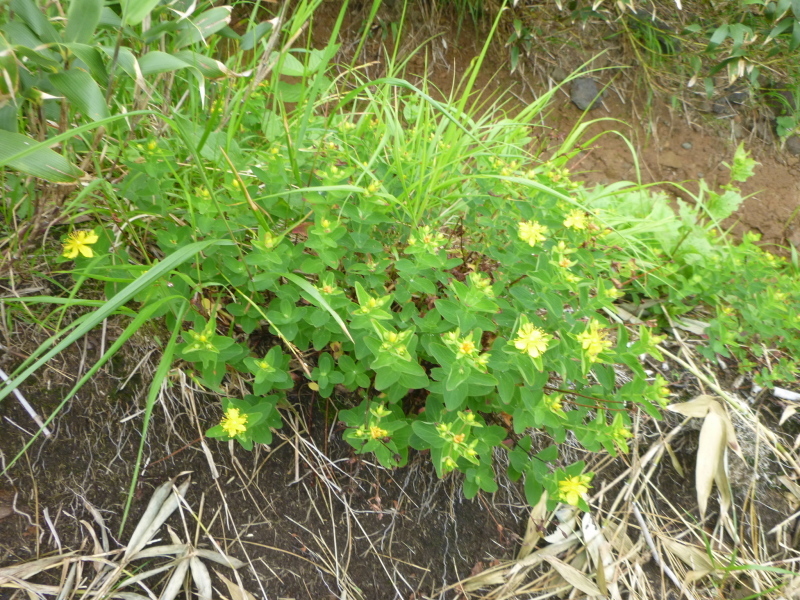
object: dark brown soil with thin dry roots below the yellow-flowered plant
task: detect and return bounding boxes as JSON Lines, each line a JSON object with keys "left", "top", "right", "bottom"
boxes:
{"left": 0, "top": 332, "right": 527, "bottom": 600}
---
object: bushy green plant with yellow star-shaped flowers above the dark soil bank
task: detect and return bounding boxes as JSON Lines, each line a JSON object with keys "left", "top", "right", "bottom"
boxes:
{"left": 64, "top": 86, "right": 792, "bottom": 508}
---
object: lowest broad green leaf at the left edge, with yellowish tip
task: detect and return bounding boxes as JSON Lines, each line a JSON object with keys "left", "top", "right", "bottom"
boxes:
{"left": 0, "top": 130, "right": 83, "bottom": 183}
